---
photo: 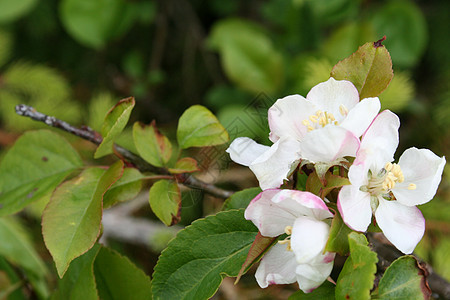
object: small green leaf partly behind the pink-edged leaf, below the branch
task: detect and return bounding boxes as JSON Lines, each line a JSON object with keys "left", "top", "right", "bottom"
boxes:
{"left": 103, "top": 168, "right": 144, "bottom": 209}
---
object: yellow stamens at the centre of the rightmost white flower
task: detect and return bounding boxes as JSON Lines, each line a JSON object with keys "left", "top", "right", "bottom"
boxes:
{"left": 361, "top": 162, "right": 416, "bottom": 196}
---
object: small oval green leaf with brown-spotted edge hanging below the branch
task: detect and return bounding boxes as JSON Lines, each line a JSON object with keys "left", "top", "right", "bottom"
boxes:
{"left": 149, "top": 180, "right": 181, "bottom": 226}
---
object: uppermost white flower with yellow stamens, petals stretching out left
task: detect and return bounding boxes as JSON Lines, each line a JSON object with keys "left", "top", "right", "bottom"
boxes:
{"left": 227, "top": 78, "right": 380, "bottom": 190}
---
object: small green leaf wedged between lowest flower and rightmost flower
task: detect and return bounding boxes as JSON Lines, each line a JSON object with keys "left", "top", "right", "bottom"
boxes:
{"left": 325, "top": 209, "right": 352, "bottom": 256}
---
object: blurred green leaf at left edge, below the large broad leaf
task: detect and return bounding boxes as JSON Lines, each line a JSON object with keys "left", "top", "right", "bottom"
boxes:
{"left": 0, "top": 218, "right": 48, "bottom": 277}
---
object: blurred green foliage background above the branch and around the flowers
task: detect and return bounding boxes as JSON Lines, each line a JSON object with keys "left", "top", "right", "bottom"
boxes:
{"left": 0, "top": 0, "right": 450, "bottom": 296}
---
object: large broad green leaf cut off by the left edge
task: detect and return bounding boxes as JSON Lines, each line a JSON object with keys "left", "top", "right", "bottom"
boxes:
{"left": 0, "top": 130, "right": 83, "bottom": 216}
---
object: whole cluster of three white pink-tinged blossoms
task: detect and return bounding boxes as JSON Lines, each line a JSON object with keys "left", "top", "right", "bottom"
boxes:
{"left": 227, "top": 78, "right": 445, "bottom": 292}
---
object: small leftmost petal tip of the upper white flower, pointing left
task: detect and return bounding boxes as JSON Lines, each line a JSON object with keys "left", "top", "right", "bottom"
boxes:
{"left": 225, "top": 137, "right": 270, "bottom": 167}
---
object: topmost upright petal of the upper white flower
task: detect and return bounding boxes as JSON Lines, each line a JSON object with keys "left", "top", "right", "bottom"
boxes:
{"left": 306, "top": 77, "right": 359, "bottom": 119}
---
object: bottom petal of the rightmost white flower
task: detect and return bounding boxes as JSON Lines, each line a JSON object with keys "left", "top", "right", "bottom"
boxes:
{"left": 375, "top": 198, "right": 425, "bottom": 254}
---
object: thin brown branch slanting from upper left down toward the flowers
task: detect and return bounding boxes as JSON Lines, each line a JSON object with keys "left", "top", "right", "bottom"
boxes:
{"left": 16, "top": 104, "right": 233, "bottom": 199}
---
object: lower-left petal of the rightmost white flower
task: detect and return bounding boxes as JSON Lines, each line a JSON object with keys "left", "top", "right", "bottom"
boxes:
{"left": 337, "top": 185, "right": 372, "bottom": 231}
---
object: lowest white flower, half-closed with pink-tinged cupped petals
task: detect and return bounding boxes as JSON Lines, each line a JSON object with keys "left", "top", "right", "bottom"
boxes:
{"left": 245, "top": 189, "right": 335, "bottom": 293}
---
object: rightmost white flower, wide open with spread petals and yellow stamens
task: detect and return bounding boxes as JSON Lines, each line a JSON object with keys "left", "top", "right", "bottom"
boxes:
{"left": 338, "top": 111, "right": 445, "bottom": 254}
